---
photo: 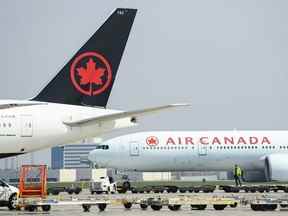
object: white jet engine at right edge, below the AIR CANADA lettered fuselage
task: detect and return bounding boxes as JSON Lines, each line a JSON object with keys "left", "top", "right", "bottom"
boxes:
{"left": 265, "top": 153, "right": 288, "bottom": 181}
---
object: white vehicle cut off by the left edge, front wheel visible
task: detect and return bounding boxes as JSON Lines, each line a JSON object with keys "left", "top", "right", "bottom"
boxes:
{"left": 0, "top": 179, "right": 19, "bottom": 210}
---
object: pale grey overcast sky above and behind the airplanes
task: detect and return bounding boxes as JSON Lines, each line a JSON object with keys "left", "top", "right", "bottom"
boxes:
{"left": 0, "top": 0, "right": 288, "bottom": 148}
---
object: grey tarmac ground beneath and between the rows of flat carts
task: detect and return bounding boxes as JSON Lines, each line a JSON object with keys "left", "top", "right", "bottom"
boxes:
{"left": 0, "top": 191, "right": 288, "bottom": 216}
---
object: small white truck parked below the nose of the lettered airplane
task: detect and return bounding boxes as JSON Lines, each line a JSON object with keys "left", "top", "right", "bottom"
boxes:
{"left": 90, "top": 176, "right": 117, "bottom": 194}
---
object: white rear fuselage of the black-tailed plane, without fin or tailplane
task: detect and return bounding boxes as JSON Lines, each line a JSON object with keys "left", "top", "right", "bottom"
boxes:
{"left": 0, "top": 100, "right": 133, "bottom": 156}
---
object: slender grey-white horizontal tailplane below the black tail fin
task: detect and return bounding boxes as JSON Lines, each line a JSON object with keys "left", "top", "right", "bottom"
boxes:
{"left": 63, "top": 104, "right": 190, "bottom": 127}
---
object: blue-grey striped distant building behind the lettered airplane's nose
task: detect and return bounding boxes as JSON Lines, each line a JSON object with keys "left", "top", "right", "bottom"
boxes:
{"left": 63, "top": 143, "right": 97, "bottom": 169}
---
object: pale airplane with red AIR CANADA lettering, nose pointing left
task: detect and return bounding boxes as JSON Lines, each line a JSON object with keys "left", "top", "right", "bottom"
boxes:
{"left": 88, "top": 131, "right": 288, "bottom": 181}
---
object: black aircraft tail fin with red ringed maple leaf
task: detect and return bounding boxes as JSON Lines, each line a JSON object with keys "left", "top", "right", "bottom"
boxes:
{"left": 32, "top": 8, "right": 137, "bottom": 107}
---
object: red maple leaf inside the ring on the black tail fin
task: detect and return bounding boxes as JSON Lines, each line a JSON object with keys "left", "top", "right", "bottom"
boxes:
{"left": 76, "top": 58, "right": 106, "bottom": 85}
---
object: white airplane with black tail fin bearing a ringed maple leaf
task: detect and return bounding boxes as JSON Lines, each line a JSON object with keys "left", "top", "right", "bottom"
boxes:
{"left": 0, "top": 8, "right": 187, "bottom": 158}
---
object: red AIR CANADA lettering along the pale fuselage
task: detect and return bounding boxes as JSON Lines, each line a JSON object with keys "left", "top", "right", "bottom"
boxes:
{"left": 166, "top": 136, "right": 272, "bottom": 145}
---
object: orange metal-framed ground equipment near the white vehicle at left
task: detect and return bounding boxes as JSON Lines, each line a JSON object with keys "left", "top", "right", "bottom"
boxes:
{"left": 19, "top": 165, "right": 47, "bottom": 198}
